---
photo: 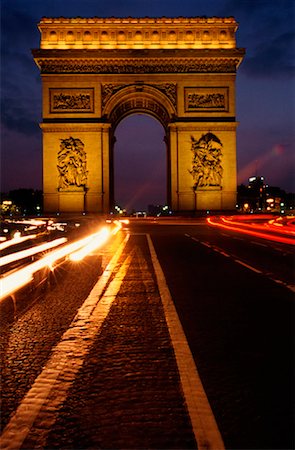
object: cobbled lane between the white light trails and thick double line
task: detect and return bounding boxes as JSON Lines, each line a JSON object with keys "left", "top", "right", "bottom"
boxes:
{"left": 0, "top": 230, "right": 122, "bottom": 427}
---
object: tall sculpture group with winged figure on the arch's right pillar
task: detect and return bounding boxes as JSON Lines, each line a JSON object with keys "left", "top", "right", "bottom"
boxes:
{"left": 189, "top": 133, "right": 223, "bottom": 191}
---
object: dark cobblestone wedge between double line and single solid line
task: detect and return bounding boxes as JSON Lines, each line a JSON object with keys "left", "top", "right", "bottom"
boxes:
{"left": 40, "top": 236, "right": 196, "bottom": 449}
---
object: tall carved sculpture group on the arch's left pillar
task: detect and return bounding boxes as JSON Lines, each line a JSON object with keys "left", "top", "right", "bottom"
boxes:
{"left": 57, "top": 137, "right": 88, "bottom": 189}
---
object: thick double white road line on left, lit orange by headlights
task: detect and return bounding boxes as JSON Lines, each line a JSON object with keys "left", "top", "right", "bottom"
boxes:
{"left": 0, "top": 234, "right": 131, "bottom": 450}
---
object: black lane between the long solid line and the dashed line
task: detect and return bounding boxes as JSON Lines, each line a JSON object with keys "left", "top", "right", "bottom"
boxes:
{"left": 152, "top": 228, "right": 294, "bottom": 449}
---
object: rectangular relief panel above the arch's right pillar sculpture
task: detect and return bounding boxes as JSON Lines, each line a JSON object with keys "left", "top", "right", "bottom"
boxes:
{"left": 184, "top": 87, "right": 229, "bottom": 113}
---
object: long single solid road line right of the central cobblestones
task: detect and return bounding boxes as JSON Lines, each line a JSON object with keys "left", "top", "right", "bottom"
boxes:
{"left": 147, "top": 234, "right": 225, "bottom": 450}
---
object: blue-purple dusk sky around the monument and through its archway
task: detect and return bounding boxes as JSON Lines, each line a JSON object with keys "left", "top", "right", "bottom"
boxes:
{"left": 1, "top": 0, "right": 295, "bottom": 209}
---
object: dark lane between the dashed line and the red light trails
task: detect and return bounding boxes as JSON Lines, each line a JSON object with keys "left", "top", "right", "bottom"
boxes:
{"left": 188, "top": 225, "right": 295, "bottom": 287}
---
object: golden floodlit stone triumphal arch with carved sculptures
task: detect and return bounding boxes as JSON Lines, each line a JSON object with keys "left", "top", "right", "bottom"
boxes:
{"left": 33, "top": 17, "right": 244, "bottom": 213}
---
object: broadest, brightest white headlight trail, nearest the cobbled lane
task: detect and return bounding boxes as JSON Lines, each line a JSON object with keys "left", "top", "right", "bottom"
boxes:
{"left": 0, "top": 223, "right": 122, "bottom": 300}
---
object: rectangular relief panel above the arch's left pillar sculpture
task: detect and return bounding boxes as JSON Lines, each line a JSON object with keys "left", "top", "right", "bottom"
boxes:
{"left": 49, "top": 88, "right": 94, "bottom": 114}
